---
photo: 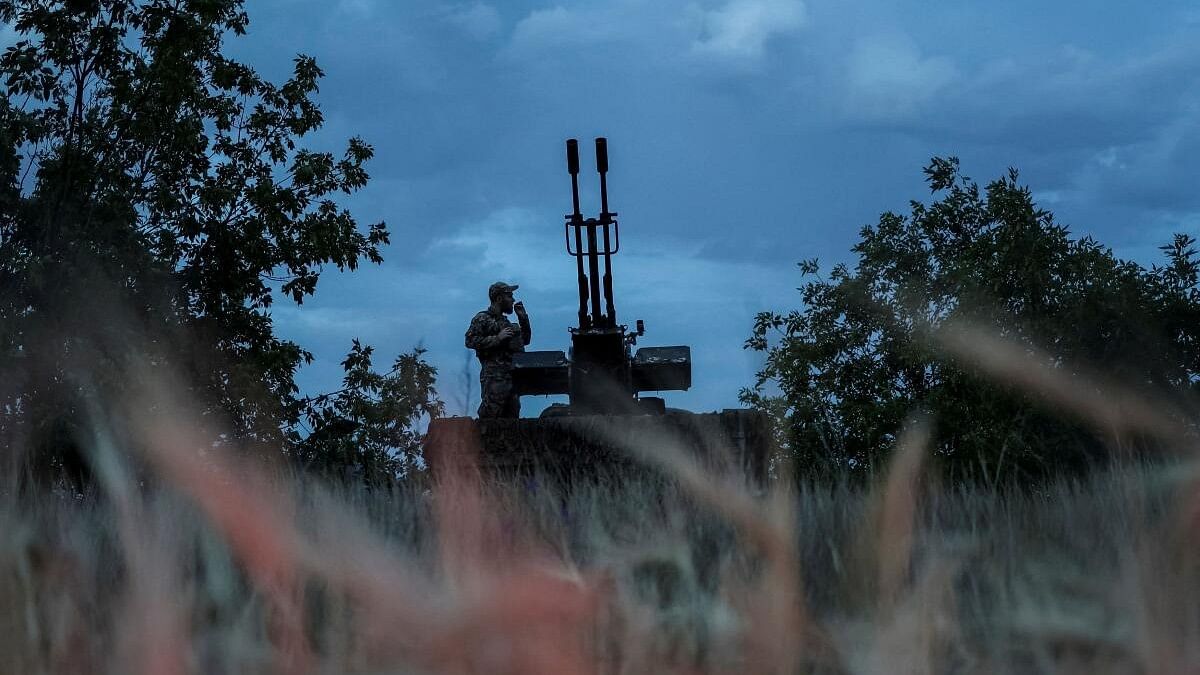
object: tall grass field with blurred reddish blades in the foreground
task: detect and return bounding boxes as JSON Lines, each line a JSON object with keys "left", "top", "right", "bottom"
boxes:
{"left": 0, "top": 321, "right": 1200, "bottom": 675}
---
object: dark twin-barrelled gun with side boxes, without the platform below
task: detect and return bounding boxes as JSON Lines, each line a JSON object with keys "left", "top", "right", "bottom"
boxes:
{"left": 512, "top": 138, "right": 691, "bottom": 416}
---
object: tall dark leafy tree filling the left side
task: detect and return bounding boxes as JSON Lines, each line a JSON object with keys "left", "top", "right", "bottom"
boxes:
{"left": 0, "top": 0, "right": 436, "bottom": 482}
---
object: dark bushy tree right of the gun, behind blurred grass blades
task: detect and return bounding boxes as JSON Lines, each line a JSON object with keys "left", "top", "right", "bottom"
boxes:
{"left": 742, "top": 157, "right": 1200, "bottom": 480}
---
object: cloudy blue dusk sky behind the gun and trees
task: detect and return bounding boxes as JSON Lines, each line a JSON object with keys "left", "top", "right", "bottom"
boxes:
{"left": 206, "top": 0, "right": 1200, "bottom": 413}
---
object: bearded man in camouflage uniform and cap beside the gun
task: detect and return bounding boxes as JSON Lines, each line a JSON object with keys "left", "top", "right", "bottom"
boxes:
{"left": 467, "top": 281, "right": 533, "bottom": 419}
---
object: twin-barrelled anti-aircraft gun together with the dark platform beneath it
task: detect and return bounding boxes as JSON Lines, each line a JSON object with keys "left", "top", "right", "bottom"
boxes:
{"left": 425, "top": 138, "right": 772, "bottom": 483}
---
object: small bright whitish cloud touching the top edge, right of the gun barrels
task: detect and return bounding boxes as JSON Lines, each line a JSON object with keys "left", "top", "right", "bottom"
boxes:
{"left": 694, "top": 0, "right": 808, "bottom": 59}
